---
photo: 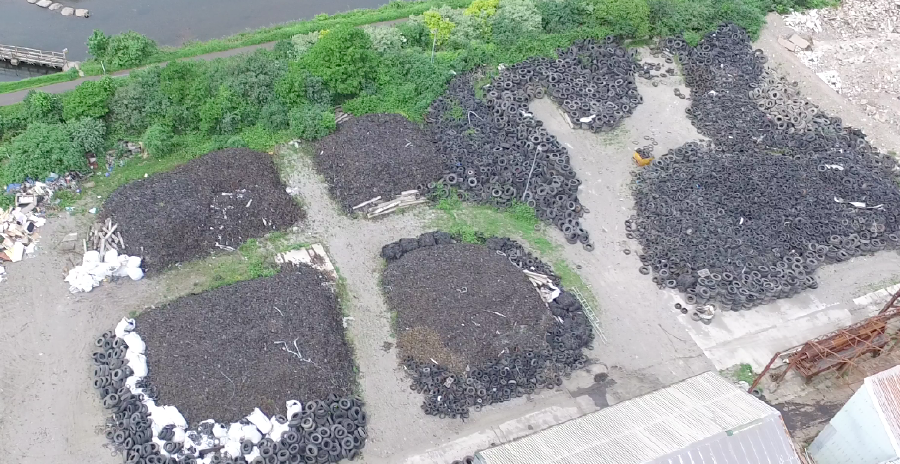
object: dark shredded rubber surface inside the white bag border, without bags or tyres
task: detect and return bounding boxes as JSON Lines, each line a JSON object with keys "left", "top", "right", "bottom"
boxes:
{"left": 136, "top": 266, "right": 354, "bottom": 425}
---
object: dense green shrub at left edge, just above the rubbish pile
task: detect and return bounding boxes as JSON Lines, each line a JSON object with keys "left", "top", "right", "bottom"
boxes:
{"left": 4, "top": 122, "right": 87, "bottom": 181}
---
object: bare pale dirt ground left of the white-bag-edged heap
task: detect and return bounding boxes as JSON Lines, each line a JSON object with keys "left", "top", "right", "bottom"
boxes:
{"left": 0, "top": 216, "right": 161, "bottom": 464}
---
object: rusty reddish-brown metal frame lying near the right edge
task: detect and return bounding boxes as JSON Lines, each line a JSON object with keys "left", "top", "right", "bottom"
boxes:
{"left": 748, "top": 290, "right": 900, "bottom": 393}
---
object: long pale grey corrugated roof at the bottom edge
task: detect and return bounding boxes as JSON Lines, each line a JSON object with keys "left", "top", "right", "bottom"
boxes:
{"left": 478, "top": 372, "right": 800, "bottom": 464}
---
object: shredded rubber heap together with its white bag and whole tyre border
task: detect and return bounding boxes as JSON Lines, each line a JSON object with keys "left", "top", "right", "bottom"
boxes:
{"left": 93, "top": 266, "right": 367, "bottom": 464}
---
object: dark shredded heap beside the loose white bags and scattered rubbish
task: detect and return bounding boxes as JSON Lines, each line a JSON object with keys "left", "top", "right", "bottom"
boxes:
{"left": 102, "top": 148, "right": 303, "bottom": 271}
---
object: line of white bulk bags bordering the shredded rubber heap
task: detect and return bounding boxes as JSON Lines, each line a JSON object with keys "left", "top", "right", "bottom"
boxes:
{"left": 115, "top": 318, "right": 303, "bottom": 464}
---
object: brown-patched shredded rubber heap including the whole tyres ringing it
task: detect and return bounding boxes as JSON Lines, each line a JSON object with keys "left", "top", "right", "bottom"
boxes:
{"left": 382, "top": 232, "right": 593, "bottom": 418}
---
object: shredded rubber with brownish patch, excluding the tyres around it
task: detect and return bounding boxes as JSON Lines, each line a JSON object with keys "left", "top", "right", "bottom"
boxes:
{"left": 383, "top": 243, "right": 553, "bottom": 372}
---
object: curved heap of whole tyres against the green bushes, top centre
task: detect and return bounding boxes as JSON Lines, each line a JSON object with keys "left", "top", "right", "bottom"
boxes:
{"left": 426, "top": 38, "right": 642, "bottom": 249}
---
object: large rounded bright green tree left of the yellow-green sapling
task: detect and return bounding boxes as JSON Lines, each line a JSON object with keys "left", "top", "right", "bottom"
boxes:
{"left": 300, "top": 26, "right": 378, "bottom": 95}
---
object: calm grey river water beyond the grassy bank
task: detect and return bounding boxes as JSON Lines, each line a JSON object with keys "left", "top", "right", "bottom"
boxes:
{"left": 0, "top": 0, "right": 387, "bottom": 64}
